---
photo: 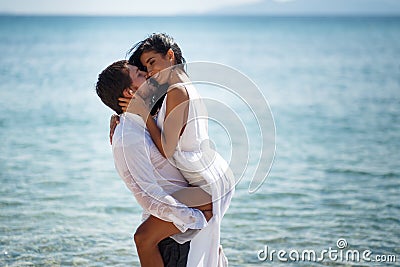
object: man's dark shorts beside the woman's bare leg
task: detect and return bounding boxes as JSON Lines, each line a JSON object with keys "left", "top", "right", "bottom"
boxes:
{"left": 158, "top": 237, "right": 190, "bottom": 267}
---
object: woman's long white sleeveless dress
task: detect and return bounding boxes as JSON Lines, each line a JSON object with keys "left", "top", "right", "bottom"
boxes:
{"left": 157, "top": 83, "right": 235, "bottom": 267}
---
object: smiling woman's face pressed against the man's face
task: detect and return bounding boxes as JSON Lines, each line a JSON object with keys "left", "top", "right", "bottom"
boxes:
{"left": 140, "top": 51, "right": 173, "bottom": 76}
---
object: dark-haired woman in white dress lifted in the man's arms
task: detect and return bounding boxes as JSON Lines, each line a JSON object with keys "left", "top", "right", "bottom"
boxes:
{"left": 115, "top": 34, "right": 234, "bottom": 266}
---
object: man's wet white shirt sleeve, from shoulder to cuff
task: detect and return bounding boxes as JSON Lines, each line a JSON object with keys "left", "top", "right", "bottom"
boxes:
{"left": 113, "top": 121, "right": 207, "bottom": 232}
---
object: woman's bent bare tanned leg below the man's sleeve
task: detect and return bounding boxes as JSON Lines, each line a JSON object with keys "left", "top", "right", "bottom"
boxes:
{"left": 134, "top": 216, "right": 180, "bottom": 267}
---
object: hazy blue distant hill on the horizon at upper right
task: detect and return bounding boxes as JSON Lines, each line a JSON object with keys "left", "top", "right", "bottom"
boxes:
{"left": 210, "top": 0, "right": 400, "bottom": 16}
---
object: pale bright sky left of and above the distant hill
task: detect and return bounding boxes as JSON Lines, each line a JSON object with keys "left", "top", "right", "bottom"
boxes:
{"left": 0, "top": 0, "right": 262, "bottom": 15}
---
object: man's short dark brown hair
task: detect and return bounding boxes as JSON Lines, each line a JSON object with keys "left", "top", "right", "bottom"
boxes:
{"left": 96, "top": 60, "right": 132, "bottom": 114}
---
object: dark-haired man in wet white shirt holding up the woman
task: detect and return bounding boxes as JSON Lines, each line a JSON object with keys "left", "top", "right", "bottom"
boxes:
{"left": 96, "top": 60, "right": 207, "bottom": 266}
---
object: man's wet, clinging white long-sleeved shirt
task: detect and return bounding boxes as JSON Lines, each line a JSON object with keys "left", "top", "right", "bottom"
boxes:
{"left": 112, "top": 113, "right": 207, "bottom": 237}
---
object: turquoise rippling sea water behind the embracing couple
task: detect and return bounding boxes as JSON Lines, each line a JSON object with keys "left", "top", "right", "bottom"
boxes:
{"left": 0, "top": 16, "right": 400, "bottom": 266}
